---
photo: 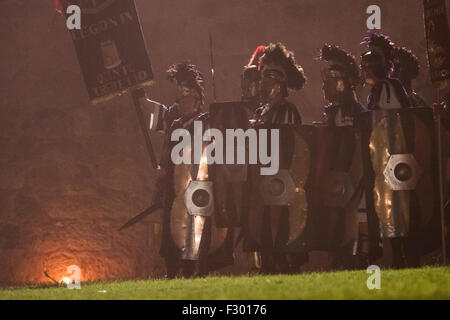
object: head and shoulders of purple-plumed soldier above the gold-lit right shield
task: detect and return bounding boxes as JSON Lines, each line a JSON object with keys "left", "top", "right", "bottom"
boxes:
{"left": 361, "top": 33, "right": 410, "bottom": 110}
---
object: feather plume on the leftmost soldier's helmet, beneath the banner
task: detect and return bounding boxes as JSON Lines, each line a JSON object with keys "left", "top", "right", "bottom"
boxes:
{"left": 166, "top": 62, "right": 205, "bottom": 103}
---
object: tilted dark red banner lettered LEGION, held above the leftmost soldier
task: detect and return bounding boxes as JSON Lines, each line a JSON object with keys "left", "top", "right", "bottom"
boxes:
{"left": 61, "top": 0, "right": 153, "bottom": 104}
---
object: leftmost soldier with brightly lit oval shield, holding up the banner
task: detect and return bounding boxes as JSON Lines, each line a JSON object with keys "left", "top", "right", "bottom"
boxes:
{"left": 139, "top": 62, "right": 225, "bottom": 278}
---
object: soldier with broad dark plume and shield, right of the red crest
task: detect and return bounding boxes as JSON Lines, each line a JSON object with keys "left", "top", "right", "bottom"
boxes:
{"left": 244, "top": 43, "right": 309, "bottom": 273}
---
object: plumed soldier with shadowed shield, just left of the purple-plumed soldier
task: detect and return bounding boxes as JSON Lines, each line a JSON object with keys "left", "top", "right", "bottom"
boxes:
{"left": 313, "top": 45, "right": 367, "bottom": 269}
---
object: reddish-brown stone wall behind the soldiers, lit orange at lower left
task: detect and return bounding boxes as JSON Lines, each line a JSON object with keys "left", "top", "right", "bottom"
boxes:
{"left": 0, "top": 0, "right": 432, "bottom": 284}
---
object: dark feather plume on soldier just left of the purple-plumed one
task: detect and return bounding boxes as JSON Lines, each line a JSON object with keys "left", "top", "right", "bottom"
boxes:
{"left": 320, "top": 44, "right": 362, "bottom": 88}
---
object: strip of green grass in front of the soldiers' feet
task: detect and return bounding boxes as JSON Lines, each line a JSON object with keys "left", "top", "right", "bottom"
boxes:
{"left": 0, "top": 267, "right": 450, "bottom": 300}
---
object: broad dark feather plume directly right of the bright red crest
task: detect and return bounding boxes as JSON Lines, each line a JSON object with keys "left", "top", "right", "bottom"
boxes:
{"left": 260, "top": 43, "right": 306, "bottom": 90}
